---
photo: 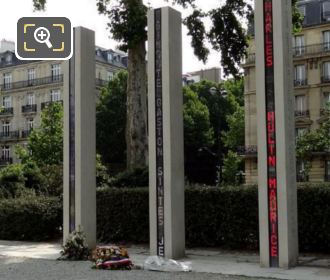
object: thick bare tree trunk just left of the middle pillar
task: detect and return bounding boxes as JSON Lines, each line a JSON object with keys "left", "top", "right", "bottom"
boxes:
{"left": 126, "top": 42, "right": 148, "bottom": 170}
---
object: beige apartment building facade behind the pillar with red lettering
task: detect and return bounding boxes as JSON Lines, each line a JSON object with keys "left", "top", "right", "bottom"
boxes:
{"left": 239, "top": 0, "right": 330, "bottom": 184}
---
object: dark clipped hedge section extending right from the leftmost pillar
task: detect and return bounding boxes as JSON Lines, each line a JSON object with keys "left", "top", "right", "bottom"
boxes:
{"left": 97, "top": 184, "right": 330, "bottom": 252}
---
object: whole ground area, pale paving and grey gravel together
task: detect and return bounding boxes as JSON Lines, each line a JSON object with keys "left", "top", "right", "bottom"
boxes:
{"left": 0, "top": 240, "right": 330, "bottom": 280}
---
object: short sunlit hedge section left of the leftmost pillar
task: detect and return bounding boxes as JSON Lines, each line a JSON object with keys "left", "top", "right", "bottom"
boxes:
{"left": 0, "top": 196, "right": 63, "bottom": 241}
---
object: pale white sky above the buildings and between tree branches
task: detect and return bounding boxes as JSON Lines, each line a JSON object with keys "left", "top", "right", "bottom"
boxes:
{"left": 0, "top": 0, "right": 227, "bottom": 73}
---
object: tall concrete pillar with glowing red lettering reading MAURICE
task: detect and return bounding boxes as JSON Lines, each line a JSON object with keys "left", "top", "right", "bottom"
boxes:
{"left": 255, "top": 0, "right": 298, "bottom": 268}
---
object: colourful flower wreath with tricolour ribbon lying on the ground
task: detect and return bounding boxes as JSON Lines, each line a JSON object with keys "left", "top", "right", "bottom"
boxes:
{"left": 92, "top": 246, "right": 133, "bottom": 270}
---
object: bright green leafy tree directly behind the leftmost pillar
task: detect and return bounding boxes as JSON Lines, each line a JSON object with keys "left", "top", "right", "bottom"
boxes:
{"left": 16, "top": 102, "right": 108, "bottom": 191}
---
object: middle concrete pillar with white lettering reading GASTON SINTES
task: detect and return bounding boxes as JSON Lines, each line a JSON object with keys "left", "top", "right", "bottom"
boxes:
{"left": 148, "top": 7, "right": 185, "bottom": 258}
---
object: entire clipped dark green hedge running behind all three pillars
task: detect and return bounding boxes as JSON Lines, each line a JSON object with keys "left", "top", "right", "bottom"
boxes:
{"left": 0, "top": 184, "right": 330, "bottom": 252}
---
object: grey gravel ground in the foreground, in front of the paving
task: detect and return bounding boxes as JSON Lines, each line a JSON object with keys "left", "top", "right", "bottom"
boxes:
{"left": 0, "top": 256, "right": 270, "bottom": 280}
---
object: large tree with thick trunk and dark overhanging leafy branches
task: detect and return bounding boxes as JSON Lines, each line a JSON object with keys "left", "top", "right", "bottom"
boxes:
{"left": 33, "top": 0, "right": 301, "bottom": 169}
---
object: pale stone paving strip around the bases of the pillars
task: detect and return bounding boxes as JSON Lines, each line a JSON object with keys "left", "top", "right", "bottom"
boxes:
{"left": 0, "top": 241, "right": 330, "bottom": 280}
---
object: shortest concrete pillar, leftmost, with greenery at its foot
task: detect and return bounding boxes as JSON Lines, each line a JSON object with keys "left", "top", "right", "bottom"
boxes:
{"left": 63, "top": 27, "right": 96, "bottom": 248}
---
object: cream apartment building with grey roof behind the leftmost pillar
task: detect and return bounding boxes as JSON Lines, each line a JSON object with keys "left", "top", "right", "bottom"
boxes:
{"left": 0, "top": 42, "right": 127, "bottom": 166}
